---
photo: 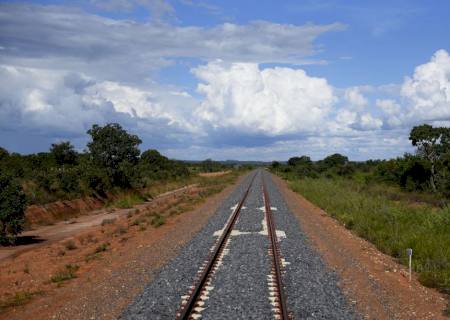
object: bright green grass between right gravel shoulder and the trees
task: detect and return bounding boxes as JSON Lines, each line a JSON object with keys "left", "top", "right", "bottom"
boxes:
{"left": 289, "top": 178, "right": 450, "bottom": 293}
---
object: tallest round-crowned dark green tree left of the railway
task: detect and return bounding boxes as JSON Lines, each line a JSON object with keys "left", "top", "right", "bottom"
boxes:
{"left": 87, "top": 123, "right": 142, "bottom": 186}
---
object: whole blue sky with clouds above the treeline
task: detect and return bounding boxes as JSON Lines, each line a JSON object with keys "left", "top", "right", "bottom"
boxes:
{"left": 0, "top": 0, "right": 450, "bottom": 161}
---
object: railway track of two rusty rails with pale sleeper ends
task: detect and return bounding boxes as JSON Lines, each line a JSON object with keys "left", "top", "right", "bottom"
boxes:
{"left": 177, "top": 173, "right": 290, "bottom": 320}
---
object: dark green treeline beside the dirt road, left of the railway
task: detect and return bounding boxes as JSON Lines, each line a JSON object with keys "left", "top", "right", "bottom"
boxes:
{"left": 0, "top": 123, "right": 223, "bottom": 243}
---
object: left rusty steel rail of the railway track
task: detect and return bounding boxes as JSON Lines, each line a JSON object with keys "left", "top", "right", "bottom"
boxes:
{"left": 177, "top": 173, "right": 257, "bottom": 320}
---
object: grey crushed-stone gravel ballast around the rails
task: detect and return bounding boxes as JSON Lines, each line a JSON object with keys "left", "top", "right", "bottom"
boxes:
{"left": 120, "top": 170, "right": 355, "bottom": 319}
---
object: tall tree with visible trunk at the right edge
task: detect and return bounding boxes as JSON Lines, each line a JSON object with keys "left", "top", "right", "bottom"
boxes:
{"left": 409, "top": 124, "right": 450, "bottom": 192}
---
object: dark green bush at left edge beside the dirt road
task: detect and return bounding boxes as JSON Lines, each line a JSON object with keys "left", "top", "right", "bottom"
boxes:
{"left": 0, "top": 174, "right": 26, "bottom": 243}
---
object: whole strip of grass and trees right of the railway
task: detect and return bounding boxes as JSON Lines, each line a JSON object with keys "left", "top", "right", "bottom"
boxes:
{"left": 271, "top": 125, "right": 450, "bottom": 293}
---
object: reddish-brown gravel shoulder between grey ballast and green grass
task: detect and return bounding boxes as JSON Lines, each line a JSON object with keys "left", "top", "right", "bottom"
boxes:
{"left": 272, "top": 175, "right": 448, "bottom": 319}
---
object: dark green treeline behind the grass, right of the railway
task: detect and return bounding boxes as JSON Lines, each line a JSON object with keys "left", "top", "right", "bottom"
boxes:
{"left": 271, "top": 124, "right": 450, "bottom": 198}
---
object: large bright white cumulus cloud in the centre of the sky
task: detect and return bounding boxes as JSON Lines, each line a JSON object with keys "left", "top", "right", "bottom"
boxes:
{"left": 193, "top": 61, "right": 336, "bottom": 136}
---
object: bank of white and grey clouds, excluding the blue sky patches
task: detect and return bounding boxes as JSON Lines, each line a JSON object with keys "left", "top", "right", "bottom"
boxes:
{"left": 0, "top": 1, "right": 450, "bottom": 160}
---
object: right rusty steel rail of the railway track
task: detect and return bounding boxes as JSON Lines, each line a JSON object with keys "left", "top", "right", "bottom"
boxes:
{"left": 262, "top": 176, "right": 289, "bottom": 320}
